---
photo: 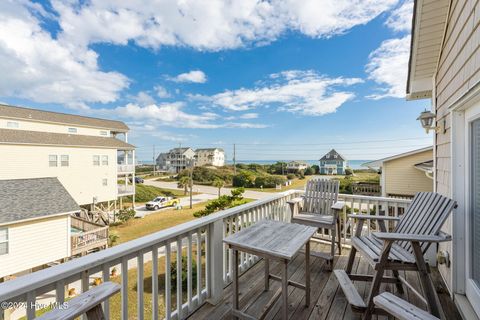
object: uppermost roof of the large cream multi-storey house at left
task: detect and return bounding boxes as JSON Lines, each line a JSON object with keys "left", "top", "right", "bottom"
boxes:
{"left": 0, "top": 104, "right": 129, "bottom": 132}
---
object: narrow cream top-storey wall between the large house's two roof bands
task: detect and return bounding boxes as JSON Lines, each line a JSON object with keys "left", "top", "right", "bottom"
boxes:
{"left": 0, "top": 117, "right": 110, "bottom": 137}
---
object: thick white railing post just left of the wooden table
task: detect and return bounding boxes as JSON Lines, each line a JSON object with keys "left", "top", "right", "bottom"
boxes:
{"left": 207, "top": 219, "right": 223, "bottom": 305}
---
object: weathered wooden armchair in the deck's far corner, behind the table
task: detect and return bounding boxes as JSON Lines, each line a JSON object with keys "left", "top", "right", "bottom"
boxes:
{"left": 288, "top": 179, "right": 345, "bottom": 269}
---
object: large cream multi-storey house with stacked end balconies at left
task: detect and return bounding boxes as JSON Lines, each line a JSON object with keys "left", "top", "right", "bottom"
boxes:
{"left": 0, "top": 105, "right": 135, "bottom": 222}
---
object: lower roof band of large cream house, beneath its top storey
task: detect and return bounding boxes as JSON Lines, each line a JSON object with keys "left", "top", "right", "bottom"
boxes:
{"left": 0, "top": 129, "right": 135, "bottom": 150}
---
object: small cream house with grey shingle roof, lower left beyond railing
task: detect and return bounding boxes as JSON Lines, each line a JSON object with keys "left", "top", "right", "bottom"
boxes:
{"left": 0, "top": 178, "right": 80, "bottom": 279}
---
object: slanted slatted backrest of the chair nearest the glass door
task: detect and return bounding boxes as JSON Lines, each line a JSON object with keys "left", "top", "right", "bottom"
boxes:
{"left": 394, "top": 192, "right": 455, "bottom": 255}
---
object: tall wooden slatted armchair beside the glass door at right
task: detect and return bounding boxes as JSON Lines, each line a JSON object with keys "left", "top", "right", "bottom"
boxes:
{"left": 335, "top": 192, "right": 456, "bottom": 319}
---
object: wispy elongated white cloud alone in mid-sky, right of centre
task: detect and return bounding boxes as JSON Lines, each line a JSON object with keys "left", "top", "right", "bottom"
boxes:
{"left": 195, "top": 70, "right": 362, "bottom": 116}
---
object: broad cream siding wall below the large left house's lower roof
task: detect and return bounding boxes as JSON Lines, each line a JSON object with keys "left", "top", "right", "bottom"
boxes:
{"left": 0, "top": 145, "right": 117, "bottom": 205}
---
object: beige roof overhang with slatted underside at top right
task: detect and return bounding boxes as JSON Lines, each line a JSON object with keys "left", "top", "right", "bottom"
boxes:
{"left": 407, "top": 0, "right": 450, "bottom": 100}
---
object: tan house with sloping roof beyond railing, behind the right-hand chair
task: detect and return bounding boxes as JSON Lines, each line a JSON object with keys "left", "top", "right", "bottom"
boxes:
{"left": 363, "top": 147, "right": 433, "bottom": 197}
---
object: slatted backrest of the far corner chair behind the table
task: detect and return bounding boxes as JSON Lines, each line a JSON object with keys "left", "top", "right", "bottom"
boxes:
{"left": 302, "top": 179, "right": 340, "bottom": 215}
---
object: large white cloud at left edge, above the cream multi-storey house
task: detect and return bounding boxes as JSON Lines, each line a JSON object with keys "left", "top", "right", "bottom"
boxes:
{"left": 0, "top": 1, "right": 129, "bottom": 109}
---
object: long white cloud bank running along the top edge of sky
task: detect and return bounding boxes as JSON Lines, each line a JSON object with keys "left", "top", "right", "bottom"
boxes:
{"left": 52, "top": 0, "right": 397, "bottom": 51}
